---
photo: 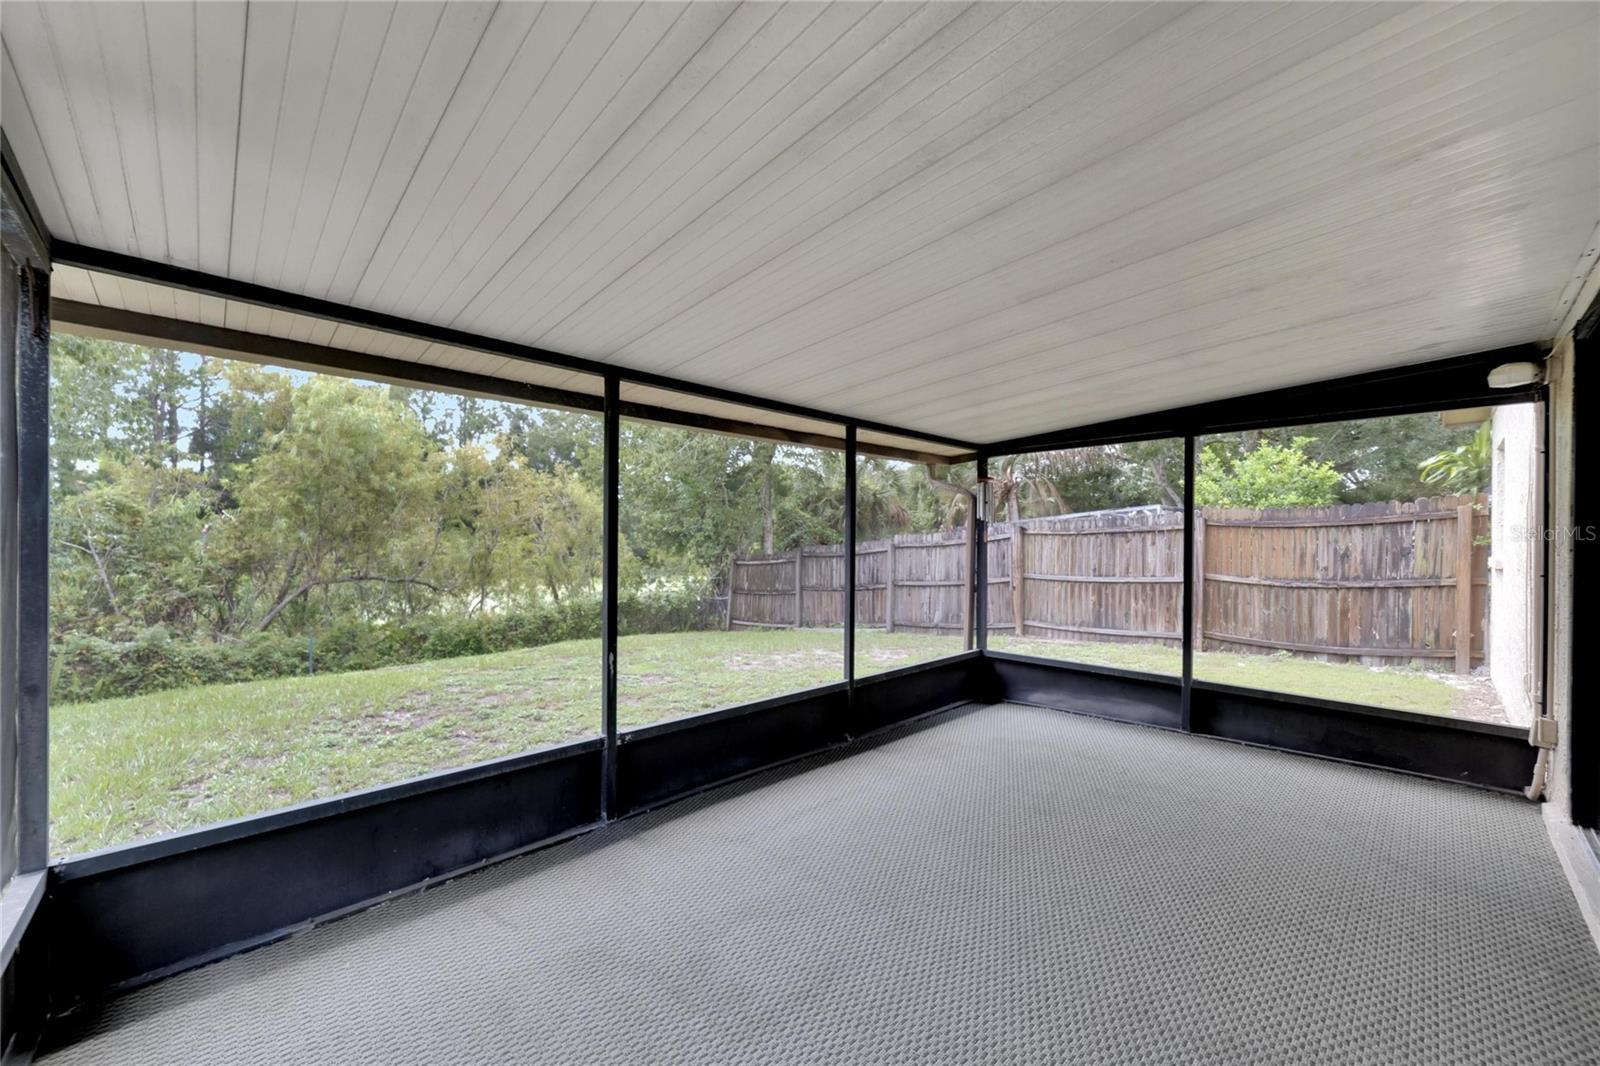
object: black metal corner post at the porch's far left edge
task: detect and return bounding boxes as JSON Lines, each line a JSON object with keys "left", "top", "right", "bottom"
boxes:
{"left": 16, "top": 266, "right": 50, "bottom": 872}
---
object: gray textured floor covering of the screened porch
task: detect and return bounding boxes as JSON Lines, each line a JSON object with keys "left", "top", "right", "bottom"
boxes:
{"left": 34, "top": 706, "right": 1600, "bottom": 1066}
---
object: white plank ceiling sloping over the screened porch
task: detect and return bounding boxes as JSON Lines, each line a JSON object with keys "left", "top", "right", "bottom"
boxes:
{"left": 0, "top": 0, "right": 1600, "bottom": 440}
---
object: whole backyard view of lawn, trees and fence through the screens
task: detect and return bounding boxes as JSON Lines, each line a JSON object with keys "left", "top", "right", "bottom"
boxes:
{"left": 40, "top": 335, "right": 1525, "bottom": 855}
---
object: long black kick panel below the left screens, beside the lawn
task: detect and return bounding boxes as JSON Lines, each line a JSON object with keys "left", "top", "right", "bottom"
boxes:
{"left": 42, "top": 653, "right": 982, "bottom": 1013}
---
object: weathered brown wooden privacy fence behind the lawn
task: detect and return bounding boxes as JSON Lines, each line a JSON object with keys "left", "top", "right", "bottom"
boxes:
{"left": 726, "top": 496, "right": 1490, "bottom": 672}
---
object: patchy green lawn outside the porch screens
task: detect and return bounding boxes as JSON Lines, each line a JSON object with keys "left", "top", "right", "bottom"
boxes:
{"left": 50, "top": 629, "right": 1484, "bottom": 855}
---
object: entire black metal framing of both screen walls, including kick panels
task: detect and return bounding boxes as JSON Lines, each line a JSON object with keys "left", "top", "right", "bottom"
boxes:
{"left": 5, "top": 146, "right": 1574, "bottom": 1043}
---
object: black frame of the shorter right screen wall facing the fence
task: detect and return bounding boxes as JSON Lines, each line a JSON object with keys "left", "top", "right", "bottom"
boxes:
{"left": 978, "top": 344, "right": 1555, "bottom": 797}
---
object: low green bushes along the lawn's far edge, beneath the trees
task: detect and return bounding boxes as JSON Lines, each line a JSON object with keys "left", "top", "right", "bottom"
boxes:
{"left": 50, "top": 587, "right": 720, "bottom": 703}
